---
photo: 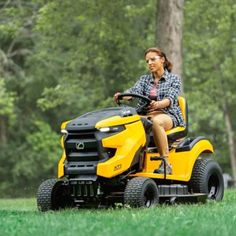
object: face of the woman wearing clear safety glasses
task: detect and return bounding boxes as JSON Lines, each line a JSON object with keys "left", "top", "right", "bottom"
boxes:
{"left": 145, "top": 52, "right": 165, "bottom": 73}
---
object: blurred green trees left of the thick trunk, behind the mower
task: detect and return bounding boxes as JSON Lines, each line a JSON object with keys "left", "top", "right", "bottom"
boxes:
{"left": 0, "top": 0, "right": 158, "bottom": 196}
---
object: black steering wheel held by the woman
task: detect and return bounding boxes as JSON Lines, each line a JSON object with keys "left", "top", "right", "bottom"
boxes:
{"left": 117, "top": 93, "right": 151, "bottom": 114}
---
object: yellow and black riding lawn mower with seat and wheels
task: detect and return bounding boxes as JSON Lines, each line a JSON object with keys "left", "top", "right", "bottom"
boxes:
{"left": 37, "top": 93, "right": 224, "bottom": 211}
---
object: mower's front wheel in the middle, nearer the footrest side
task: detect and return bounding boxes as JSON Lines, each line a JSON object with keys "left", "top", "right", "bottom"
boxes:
{"left": 124, "top": 177, "right": 159, "bottom": 207}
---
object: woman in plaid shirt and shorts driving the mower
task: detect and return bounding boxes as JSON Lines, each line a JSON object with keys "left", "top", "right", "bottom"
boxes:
{"left": 114, "top": 48, "right": 185, "bottom": 174}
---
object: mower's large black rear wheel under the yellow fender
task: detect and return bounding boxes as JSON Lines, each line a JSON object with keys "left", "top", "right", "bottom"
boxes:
{"left": 189, "top": 158, "right": 224, "bottom": 201}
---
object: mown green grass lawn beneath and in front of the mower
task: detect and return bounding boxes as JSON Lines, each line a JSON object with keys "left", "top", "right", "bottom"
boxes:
{"left": 0, "top": 189, "right": 236, "bottom": 236}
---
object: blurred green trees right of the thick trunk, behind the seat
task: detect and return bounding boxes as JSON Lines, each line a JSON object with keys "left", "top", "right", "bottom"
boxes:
{"left": 184, "top": 0, "right": 236, "bottom": 183}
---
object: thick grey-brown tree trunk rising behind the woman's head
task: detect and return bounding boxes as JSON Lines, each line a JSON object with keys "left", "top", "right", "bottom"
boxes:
{"left": 156, "top": 0, "right": 184, "bottom": 90}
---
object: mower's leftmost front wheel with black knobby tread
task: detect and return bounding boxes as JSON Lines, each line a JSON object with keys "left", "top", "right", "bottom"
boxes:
{"left": 37, "top": 179, "right": 72, "bottom": 211}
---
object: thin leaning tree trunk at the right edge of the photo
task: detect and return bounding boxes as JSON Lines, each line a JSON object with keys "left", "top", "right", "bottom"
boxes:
{"left": 224, "top": 106, "right": 236, "bottom": 186}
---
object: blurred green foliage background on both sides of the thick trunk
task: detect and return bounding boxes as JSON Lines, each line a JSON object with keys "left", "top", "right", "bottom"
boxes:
{"left": 0, "top": 0, "right": 236, "bottom": 196}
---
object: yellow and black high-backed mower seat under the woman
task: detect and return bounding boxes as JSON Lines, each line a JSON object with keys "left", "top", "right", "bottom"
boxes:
{"left": 166, "top": 96, "right": 188, "bottom": 142}
